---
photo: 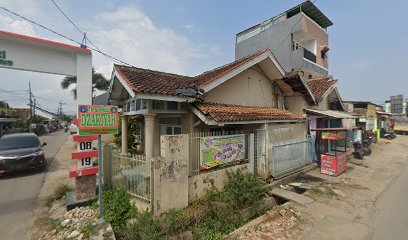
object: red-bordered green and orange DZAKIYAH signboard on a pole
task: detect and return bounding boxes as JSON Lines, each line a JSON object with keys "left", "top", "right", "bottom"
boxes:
{"left": 78, "top": 105, "right": 119, "bottom": 135}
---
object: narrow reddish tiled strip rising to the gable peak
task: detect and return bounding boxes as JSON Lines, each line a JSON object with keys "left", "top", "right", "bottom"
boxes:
{"left": 194, "top": 49, "right": 269, "bottom": 88}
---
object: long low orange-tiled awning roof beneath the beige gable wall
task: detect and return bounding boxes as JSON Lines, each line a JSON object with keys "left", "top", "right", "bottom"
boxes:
{"left": 196, "top": 103, "right": 305, "bottom": 123}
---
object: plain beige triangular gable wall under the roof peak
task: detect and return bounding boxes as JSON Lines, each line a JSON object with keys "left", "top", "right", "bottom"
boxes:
{"left": 204, "top": 67, "right": 277, "bottom": 107}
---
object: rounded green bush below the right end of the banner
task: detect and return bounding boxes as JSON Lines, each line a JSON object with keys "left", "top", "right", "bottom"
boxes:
{"left": 222, "top": 170, "right": 262, "bottom": 209}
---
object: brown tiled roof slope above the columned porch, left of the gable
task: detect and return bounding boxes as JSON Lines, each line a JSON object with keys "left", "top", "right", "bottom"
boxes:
{"left": 114, "top": 64, "right": 193, "bottom": 95}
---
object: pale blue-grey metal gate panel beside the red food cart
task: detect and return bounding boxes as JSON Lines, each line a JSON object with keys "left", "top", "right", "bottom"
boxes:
{"left": 271, "top": 136, "right": 315, "bottom": 178}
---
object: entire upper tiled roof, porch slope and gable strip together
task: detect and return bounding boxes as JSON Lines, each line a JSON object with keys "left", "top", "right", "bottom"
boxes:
{"left": 114, "top": 49, "right": 269, "bottom": 95}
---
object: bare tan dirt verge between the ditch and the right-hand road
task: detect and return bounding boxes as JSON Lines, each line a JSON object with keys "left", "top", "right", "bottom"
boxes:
{"left": 234, "top": 136, "right": 408, "bottom": 240}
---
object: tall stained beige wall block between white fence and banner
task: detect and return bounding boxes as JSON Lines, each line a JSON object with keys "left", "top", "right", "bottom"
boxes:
{"left": 153, "top": 134, "right": 189, "bottom": 214}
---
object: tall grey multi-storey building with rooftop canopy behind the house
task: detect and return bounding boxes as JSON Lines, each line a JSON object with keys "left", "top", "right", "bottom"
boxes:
{"left": 235, "top": 1, "right": 333, "bottom": 79}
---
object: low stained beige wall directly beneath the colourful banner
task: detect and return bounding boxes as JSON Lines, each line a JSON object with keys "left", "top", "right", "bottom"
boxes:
{"left": 188, "top": 163, "right": 249, "bottom": 201}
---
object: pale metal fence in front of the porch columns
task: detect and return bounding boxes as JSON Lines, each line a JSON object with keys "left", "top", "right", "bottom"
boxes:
{"left": 104, "top": 145, "right": 151, "bottom": 202}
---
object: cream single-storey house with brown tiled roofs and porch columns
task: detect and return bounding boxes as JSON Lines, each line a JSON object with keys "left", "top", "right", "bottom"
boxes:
{"left": 109, "top": 49, "right": 307, "bottom": 180}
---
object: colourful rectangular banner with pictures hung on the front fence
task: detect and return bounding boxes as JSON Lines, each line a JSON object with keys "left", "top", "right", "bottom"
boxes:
{"left": 200, "top": 134, "right": 245, "bottom": 169}
